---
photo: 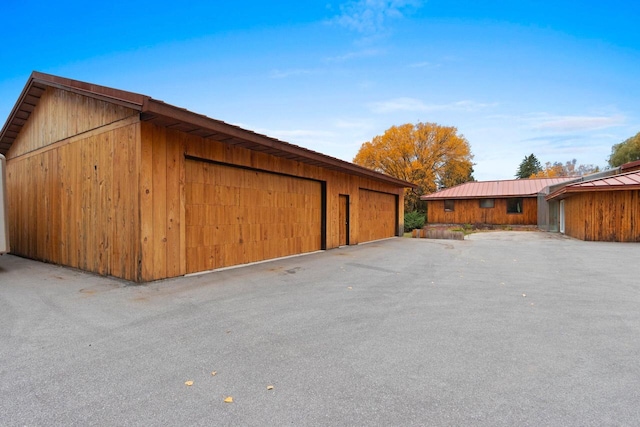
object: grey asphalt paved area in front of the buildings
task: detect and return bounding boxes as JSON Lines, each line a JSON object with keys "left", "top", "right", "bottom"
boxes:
{"left": 0, "top": 232, "right": 640, "bottom": 426}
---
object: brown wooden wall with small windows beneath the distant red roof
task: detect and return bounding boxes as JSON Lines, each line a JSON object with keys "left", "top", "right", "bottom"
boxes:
{"left": 427, "top": 197, "right": 538, "bottom": 225}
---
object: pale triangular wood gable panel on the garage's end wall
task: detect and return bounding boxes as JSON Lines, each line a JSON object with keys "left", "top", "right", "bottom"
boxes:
{"left": 6, "top": 87, "right": 137, "bottom": 159}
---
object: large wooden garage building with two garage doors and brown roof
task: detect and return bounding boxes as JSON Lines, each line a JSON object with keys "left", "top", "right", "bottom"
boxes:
{"left": 0, "top": 72, "right": 413, "bottom": 282}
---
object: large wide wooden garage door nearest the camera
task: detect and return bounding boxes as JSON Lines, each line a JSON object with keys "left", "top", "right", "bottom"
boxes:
{"left": 185, "top": 160, "right": 322, "bottom": 273}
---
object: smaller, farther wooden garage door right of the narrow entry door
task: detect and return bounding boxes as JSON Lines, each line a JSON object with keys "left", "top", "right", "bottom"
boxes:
{"left": 358, "top": 188, "right": 398, "bottom": 242}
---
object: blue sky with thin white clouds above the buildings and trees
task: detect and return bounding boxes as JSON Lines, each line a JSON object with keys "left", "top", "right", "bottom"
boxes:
{"left": 0, "top": 0, "right": 640, "bottom": 180}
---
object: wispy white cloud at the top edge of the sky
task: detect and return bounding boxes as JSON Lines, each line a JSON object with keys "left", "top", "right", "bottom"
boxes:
{"left": 332, "top": 0, "right": 422, "bottom": 34}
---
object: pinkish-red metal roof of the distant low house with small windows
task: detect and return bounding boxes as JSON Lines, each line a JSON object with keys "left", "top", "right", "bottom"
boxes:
{"left": 420, "top": 177, "right": 576, "bottom": 200}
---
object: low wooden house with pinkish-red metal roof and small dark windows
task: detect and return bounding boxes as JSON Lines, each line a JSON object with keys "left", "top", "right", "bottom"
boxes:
{"left": 420, "top": 177, "right": 575, "bottom": 226}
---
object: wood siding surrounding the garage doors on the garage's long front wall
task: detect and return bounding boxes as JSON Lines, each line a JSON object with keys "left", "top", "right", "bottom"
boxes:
{"left": 140, "top": 122, "right": 404, "bottom": 281}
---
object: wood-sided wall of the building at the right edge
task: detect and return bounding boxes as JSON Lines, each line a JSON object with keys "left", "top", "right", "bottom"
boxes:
{"left": 564, "top": 190, "right": 640, "bottom": 242}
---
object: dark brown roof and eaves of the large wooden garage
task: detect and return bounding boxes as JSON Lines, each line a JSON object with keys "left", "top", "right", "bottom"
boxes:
{"left": 0, "top": 71, "right": 417, "bottom": 188}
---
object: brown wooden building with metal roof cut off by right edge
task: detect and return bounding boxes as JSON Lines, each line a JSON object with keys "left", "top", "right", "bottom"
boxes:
{"left": 546, "top": 171, "right": 640, "bottom": 242}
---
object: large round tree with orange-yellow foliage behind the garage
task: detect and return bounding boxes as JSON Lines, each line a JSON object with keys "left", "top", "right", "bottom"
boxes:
{"left": 353, "top": 122, "right": 473, "bottom": 212}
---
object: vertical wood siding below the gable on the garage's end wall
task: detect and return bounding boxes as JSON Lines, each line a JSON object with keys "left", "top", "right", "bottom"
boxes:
{"left": 7, "top": 121, "right": 139, "bottom": 280}
